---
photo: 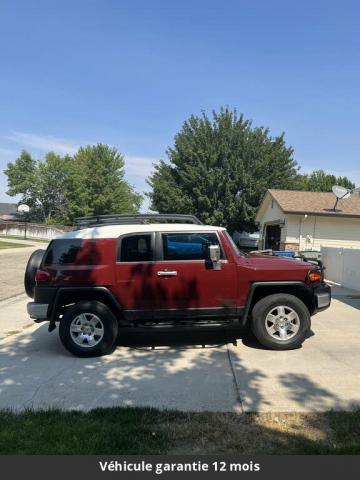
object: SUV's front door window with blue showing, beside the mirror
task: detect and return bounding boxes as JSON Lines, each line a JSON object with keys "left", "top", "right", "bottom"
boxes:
{"left": 162, "top": 233, "right": 220, "bottom": 260}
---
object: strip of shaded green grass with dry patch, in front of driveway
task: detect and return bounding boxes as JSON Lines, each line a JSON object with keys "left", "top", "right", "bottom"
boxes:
{"left": 0, "top": 408, "right": 360, "bottom": 454}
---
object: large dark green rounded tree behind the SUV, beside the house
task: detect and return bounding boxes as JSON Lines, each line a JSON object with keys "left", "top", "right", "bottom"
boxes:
{"left": 148, "top": 108, "right": 297, "bottom": 231}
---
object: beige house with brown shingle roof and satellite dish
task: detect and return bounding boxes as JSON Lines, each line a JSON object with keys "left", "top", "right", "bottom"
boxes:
{"left": 256, "top": 189, "right": 360, "bottom": 251}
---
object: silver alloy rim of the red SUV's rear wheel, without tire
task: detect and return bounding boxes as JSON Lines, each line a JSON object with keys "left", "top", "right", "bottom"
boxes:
{"left": 70, "top": 313, "right": 105, "bottom": 348}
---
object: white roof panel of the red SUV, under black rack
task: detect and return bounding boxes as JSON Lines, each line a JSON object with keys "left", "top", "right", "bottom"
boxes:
{"left": 56, "top": 223, "right": 226, "bottom": 239}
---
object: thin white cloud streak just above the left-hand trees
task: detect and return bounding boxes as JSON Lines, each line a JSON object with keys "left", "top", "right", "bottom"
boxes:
{"left": 6, "top": 132, "right": 80, "bottom": 154}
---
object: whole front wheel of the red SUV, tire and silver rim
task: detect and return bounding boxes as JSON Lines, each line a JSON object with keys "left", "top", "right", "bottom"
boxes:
{"left": 251, "top": 294, "right": 311, "bottom": 350}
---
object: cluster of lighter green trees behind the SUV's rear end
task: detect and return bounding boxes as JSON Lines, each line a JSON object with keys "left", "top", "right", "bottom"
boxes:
{"left": 4, "top": 144, "right": 142, "bottom": 224}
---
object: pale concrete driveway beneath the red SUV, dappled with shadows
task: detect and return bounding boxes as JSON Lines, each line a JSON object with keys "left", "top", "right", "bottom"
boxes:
{"left": 0, "top": 289, "right": 360, "bottom": 412}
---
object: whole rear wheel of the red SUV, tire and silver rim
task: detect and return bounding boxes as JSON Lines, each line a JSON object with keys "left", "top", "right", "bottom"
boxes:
{"left": 59, "top": 301, "right": 118, "bottom": 357}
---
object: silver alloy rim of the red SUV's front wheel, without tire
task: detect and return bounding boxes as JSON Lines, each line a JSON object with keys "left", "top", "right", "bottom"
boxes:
{"left": 265, "top": 305, "right": 300, "bottom": 341}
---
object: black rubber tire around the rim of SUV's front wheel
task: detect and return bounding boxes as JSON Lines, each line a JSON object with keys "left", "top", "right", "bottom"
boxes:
{"left": 251, "top": 293, "right": 311, "bottom": 350}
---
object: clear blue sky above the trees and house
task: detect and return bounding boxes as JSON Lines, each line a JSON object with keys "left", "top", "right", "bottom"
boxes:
{"left": 0, "top": 0, "right": 360, "bottom": 208}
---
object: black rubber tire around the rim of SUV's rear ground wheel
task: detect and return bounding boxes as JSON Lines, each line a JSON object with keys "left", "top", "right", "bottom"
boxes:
{"left": 59, "top": 300, "right": 118, "bottom": 357}
